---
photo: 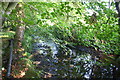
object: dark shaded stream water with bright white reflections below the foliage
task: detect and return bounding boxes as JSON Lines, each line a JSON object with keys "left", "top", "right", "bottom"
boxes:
{"left": 33, "top": 36, "right": 120, "bottom": 79}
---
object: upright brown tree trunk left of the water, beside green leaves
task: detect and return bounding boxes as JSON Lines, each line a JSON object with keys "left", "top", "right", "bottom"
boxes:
{"left": 14, "top": 4, "right": 25, "bottom": 57}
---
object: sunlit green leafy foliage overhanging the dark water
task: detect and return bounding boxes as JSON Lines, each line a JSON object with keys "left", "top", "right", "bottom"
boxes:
{"left": 20, "top": 2, "right": 119, "bottom": 54}
